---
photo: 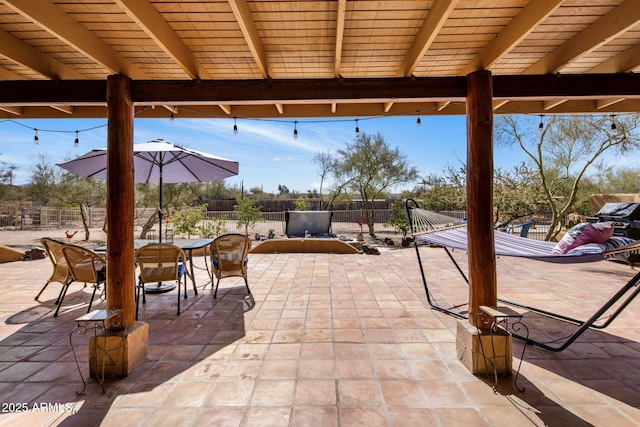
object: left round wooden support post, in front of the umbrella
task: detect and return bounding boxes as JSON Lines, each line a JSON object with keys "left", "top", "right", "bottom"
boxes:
{"left": 107, "top": 75, "right": 135, "bottom": 329}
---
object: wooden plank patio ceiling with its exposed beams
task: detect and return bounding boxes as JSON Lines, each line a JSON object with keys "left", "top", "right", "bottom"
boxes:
{"left": 0, "top": 0, "right": 640, "bottom": 118}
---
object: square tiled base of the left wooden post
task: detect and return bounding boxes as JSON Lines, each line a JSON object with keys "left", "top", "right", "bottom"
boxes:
{"left": 89, "top": 322, "right": 149, "bottom": 378}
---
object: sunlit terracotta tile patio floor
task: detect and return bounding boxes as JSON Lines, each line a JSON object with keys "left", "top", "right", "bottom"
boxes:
{"left": 0, "top": 242, "right": 640, "bottom": 427}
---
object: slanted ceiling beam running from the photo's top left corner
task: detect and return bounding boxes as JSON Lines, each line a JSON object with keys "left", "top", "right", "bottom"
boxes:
{"left": 3, "top": 0, "right": 148, "bottom": 79}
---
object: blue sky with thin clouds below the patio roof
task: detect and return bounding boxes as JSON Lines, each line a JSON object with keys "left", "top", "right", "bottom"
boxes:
{"left": 0, "top": 116, "right": 523, "bottom": 192}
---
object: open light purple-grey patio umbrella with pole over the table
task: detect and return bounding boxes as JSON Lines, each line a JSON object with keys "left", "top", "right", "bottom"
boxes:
{"left": 58, "top": 139, "right": 238, "bottom": 292}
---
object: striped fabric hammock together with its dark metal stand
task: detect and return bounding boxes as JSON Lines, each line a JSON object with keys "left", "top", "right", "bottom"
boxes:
{"left": 405, "top": 199, "right": 640, "bottom": 351}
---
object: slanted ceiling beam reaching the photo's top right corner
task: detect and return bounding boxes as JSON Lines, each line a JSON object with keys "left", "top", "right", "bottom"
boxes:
{"left": 524, "top": 0, "right": 640, "bottom": 74}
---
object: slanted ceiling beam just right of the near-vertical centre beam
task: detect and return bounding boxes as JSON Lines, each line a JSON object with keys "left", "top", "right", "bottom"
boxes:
{"left": 396, "top": 0, "right": 458, "bottom": 77}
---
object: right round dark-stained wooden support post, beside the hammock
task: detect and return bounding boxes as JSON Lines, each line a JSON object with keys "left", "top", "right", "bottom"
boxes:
{"left": 467, "top": 70, "right": 498, "bottom": 324}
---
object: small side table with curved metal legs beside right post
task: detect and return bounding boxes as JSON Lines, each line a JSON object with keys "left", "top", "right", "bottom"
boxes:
{"left": 476, "top": 305, "right": 529, "bottom": 393}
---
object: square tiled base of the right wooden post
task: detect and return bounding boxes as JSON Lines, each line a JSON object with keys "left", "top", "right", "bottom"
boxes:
{"left": 456, "top": 319, "right": 513, "bottom": 375}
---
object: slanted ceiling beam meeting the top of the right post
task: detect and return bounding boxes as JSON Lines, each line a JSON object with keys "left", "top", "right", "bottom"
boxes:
{"left": 460, "top": 0, "right": 564, "bottom": 76}
